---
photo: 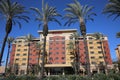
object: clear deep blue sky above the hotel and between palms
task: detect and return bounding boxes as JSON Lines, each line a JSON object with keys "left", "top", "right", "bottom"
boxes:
{"left": 0, "top": 0, "right": 120, "bottom": 64}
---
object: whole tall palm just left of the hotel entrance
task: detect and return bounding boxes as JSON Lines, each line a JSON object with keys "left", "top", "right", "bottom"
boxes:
{"left": 31, "top": 0, "right": 61, "bottom": 80}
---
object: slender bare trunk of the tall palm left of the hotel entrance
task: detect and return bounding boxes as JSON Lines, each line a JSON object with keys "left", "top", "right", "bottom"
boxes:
{"left": 40, "top": 36, "right": 46, "bottom": 80}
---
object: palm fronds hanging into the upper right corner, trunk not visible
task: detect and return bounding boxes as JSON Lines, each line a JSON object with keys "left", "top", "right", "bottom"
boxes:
{"left": 103, "top": 0, "right": 120, "bottom": 20}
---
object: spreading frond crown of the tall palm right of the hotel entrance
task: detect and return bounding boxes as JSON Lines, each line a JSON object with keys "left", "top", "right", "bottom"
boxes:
{"left": 63, "top": 0, "right": 96, "bottom": 26}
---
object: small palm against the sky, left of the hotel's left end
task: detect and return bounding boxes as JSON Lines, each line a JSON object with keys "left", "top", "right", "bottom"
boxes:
{"left": 5, "top": 37, "right": 14, "bottom": 73}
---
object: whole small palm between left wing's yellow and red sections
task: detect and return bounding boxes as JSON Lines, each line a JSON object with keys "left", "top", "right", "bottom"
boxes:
{"left": 25, "top": 34, "right": 33, "bottom": 74}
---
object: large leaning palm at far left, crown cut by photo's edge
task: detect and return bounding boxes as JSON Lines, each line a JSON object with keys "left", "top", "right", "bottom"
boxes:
{"left": 0, "top": 0, "right": 29, "bottom": 64}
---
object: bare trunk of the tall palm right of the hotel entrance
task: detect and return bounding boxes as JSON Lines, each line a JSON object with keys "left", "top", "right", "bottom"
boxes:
{"left": 83, "top": 35, "right": 91, "bottom": 77}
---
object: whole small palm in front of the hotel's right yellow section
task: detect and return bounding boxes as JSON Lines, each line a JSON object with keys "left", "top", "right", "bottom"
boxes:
{"left": 94, "top": 33, "right": 108, "bottom": 74}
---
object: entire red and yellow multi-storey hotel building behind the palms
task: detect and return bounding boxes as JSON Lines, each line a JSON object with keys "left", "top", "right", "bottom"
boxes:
{"left": 10, "top": 29, "right": 112, "bottom": 75}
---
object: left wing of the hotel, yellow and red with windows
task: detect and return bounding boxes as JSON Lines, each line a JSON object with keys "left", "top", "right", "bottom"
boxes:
{"left": 10, "top": 36, "right": 39, "bottom": 74}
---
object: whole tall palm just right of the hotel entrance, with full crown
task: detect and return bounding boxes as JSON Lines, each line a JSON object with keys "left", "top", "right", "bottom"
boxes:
{"left": 63, "top": 0, "right": 96, "bottom": 77}
